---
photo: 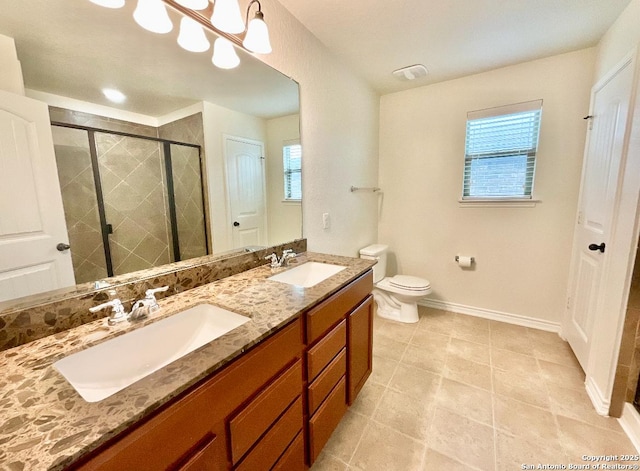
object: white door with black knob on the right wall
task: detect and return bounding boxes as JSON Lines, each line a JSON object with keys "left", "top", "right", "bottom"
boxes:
{"left": 563, "top": 58, "right": 633, "bottom": 370}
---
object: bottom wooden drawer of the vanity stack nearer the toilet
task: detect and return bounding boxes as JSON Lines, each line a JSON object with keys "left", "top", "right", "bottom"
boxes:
{"left": 309, "top": 378, "right": 347, "bottom": 463}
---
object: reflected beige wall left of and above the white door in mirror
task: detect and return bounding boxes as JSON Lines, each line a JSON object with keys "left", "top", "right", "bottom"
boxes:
{"left": 202, "top": 102, "right": 266, "bottom": 253}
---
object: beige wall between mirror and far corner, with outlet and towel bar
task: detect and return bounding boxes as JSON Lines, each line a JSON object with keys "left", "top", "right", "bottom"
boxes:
{"left": 256, "top": 1, "right": 378, "bottom": 256}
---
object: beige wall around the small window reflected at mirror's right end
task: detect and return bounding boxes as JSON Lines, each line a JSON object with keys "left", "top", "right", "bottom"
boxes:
{"left": 266, "top": 114, "right": 304, "bottom": 245}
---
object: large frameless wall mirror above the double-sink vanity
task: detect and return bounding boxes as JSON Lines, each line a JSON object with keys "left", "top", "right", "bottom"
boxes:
{"left": 0, "top": 0, "right": 302, "bottom": 310}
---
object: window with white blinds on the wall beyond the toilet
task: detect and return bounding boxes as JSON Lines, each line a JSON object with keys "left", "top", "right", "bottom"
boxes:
{"left": 462, "top": 100, "right": 542, "bottom": 200}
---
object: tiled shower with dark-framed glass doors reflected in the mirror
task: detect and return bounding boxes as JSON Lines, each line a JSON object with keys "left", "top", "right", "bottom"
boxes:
{"left": 52, "top": 112, "right": 210, "bottom": 283}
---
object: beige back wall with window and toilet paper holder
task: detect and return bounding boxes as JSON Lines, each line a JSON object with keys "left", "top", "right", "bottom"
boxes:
{"left": 378, "top": 49, "right": 595, "bottom": 327}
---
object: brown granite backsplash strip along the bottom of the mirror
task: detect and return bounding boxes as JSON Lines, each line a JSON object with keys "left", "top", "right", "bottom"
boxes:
{"left": 0, "top": 239, "right": 307, "bottom": 351}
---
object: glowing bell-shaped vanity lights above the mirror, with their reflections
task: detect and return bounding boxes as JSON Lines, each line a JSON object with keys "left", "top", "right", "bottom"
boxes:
{"left": 89, "top": 0, "right": 272, "bottom": 69}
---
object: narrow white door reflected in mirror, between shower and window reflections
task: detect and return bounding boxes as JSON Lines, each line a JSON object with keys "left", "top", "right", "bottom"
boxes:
{"left": 225, "top": 136, "right": 267, "bottom": 249}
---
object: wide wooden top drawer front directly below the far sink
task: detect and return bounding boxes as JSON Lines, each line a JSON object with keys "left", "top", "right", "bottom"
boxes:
{"left": 306, "top": 270, "right": 373, "bottom": 345}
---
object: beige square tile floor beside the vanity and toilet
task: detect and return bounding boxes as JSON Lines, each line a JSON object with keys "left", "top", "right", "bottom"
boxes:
{"left": 312, "top": 307, "right": 640, "bottom": 471}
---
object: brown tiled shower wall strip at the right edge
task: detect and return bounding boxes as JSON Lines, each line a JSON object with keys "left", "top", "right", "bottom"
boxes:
{"left": 609, "top": 243, "right": 640, "bottom": 417}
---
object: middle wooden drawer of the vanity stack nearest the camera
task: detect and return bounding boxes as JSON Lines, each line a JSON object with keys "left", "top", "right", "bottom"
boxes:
{"left": 235, "top": 397, "right": 303, "bottom": 471}
